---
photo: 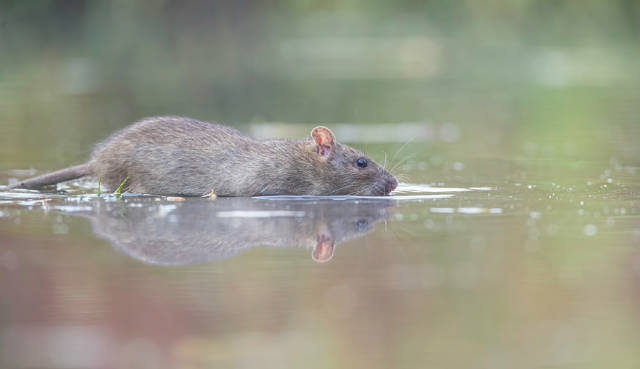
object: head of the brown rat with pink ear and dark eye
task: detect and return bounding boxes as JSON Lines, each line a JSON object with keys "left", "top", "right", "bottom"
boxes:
{"left": 311, "top": 126, "right": 398, "bottom": 196}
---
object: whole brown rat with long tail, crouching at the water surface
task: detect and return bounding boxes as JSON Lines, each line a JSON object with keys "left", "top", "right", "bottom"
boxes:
{"left": 9, "top": 116, "right": 398, "bottom": 196}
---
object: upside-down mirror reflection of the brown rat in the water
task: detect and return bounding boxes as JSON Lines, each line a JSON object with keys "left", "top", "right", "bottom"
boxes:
{"left": 82, "top": 198, "right": 395, "bottom": 265}
